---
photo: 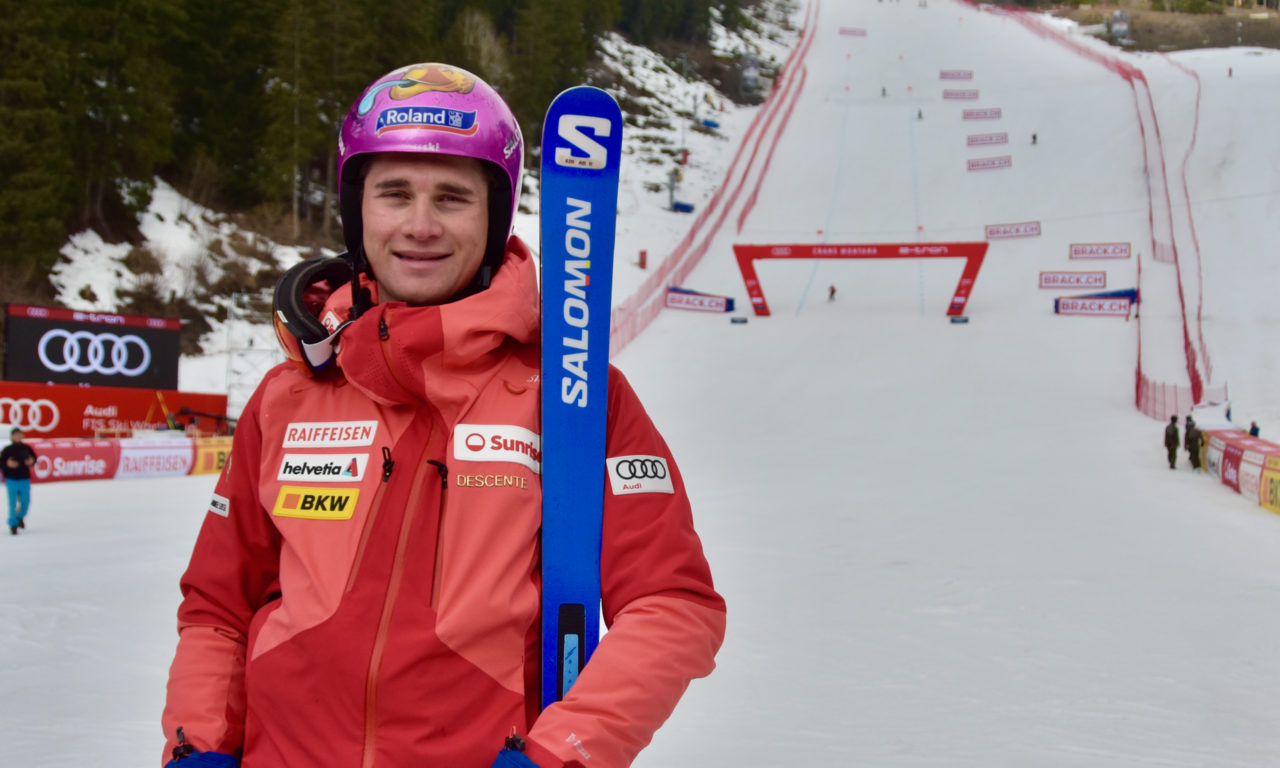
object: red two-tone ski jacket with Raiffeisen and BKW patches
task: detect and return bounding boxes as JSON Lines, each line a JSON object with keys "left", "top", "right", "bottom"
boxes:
{"left": 163, "top": 238, "right": 724, "bottom": 768}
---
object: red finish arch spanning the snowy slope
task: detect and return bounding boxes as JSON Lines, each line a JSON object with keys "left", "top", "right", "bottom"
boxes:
{"left": 733, "top": 241, "right": 987, "bottom": 316}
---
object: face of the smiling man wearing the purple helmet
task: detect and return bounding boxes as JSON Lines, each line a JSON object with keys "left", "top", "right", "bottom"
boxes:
{"left": 361, "top": 154, "right": 489, "bottom": 306}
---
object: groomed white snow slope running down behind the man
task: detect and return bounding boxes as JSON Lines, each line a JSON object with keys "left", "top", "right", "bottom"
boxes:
{"left": 0, "top": 0, "right": 1280, "bottom": 768}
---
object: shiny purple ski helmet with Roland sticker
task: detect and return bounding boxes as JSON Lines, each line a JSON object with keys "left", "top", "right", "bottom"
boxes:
{"left": 338, "top": 63, "right": 525, "bottom": 299}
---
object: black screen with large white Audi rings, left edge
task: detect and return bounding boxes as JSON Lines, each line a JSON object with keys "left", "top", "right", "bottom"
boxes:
{"left": 4, "top": 305, "right": 182, "bottom": 389}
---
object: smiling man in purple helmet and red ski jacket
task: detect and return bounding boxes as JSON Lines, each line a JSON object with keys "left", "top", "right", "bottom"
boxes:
{"left": 163, "top": 64, "right": 724, "bottom": 768}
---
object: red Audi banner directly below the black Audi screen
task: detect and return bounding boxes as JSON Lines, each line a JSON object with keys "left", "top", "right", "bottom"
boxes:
{"left": 0, "top": 381, "right": 227, "bottom": 438}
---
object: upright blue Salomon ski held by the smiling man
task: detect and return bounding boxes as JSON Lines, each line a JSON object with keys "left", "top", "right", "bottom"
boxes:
{"left": 540, "top": 86, "right": 622, "bottom": 707}
